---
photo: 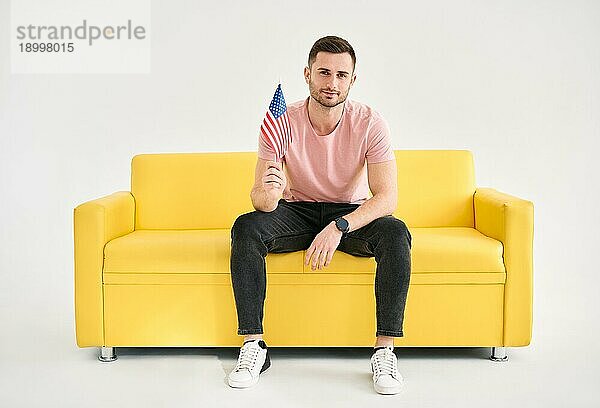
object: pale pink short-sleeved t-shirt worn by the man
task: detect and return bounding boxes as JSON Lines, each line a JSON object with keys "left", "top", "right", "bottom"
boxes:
{"left": 258, "top": 98, "right": 395, "bottom": 204}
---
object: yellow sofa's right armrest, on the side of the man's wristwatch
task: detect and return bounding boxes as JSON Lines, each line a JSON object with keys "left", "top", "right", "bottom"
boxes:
{"left": 473, "top": 188, "right": 533, "bottom": 347}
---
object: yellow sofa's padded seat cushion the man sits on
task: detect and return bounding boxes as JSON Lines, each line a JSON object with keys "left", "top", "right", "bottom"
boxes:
{"left": 104, "top": 227, "right": 505, "bottom": 283}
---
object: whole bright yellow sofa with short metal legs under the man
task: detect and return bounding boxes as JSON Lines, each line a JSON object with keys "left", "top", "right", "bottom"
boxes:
{"left": 73, "top": 150, "right": 533, "bottom": 361}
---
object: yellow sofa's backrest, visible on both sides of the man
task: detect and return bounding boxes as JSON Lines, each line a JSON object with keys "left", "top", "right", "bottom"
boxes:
{"left": 131, "top": 150, "right": 475, "bottom": 229}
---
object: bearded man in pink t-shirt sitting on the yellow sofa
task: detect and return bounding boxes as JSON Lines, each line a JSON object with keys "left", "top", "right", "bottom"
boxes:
{"left": 228, "top": 36, "right": 412, "bottom": 394}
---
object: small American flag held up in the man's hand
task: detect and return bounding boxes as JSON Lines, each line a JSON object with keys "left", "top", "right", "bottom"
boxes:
{"left": 260, "top": 84, "right": 292, "bottom": 162}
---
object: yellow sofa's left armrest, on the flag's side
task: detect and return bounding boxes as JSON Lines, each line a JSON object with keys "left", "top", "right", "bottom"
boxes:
{"left": 73, "top": 191, "right": 135, "bottom": 347}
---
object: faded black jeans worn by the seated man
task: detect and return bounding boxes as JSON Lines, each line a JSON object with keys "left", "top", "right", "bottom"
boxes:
{"left": 230, "top": 199, "right": 412, "bottom": 337}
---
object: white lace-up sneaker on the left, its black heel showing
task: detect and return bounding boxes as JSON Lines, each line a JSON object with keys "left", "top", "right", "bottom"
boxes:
{"left": 227, "top": 339, "right": 271, "bottom": 388}
